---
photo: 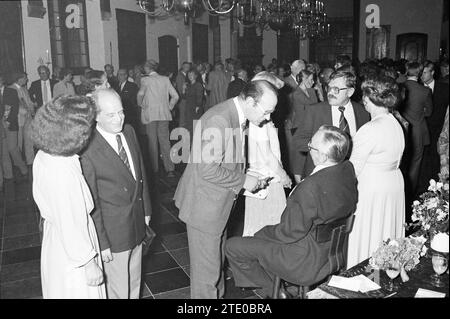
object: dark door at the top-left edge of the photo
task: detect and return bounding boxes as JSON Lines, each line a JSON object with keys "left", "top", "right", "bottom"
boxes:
{"left": 0, "top": 1, "right": 23, "bottom": 75}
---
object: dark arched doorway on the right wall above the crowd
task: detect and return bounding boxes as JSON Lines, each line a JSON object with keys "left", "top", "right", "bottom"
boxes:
{"left": 396, "top": 33, "right": 428, "bottom": 62}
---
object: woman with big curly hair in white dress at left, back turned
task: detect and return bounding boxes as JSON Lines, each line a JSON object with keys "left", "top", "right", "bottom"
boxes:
{"left": 30, "top": 96, "right": 106, "bottom": 299}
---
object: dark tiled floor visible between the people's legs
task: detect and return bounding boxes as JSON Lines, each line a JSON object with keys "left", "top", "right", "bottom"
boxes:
{"left": 0, "top": 165, "right": 258, "bottom": 299}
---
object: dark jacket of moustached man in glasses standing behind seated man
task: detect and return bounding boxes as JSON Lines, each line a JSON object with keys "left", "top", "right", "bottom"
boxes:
{"left": 292, "top": 102, "right": 370, "bottom": 176}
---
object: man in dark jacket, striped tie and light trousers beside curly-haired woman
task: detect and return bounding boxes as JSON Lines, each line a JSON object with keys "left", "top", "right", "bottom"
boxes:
{"left": 81, "top": 89, "right": 152, "bottom": 299}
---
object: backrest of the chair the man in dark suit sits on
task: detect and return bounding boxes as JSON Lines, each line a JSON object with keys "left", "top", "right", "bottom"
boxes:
{"left": 316, "top": 213, "right": 355, "bottom": 274}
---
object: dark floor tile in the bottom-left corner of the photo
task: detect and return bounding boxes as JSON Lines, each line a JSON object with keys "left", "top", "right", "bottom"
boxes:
{"left": 0, "top": 277, "right": 42, "bottom": 299}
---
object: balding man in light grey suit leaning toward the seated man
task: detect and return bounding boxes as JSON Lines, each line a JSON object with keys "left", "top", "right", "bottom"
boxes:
{"left": 174, "top": 81, "right": 277, "bottom": 299}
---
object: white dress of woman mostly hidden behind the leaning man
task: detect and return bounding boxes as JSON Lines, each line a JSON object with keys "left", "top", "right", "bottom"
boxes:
{"left": 243, "top": 122, "right": 286, "bottom": 236}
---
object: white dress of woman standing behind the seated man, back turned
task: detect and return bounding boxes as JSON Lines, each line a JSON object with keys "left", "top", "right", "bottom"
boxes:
{"left": 347, "top": 114, "right": 405, "bottom": 268}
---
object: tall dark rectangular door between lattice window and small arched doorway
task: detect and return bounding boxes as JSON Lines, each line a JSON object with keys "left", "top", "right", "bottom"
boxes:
{"left": 116, "top": 9, "right": 147, "bottom": 67}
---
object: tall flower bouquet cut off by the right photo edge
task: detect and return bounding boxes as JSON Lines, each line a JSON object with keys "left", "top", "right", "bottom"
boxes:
{"left": 408, "top": 179, "right": 449, "bottom": 239}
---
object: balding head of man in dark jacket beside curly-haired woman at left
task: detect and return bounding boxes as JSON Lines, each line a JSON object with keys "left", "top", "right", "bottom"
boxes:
{"left": 92, "top": 89, "right": 125, "bottom": 134}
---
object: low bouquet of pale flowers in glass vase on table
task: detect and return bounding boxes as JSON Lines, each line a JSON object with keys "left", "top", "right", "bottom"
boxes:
{"left": 369, "top": 238, "right": 426, "bottom": 282}
